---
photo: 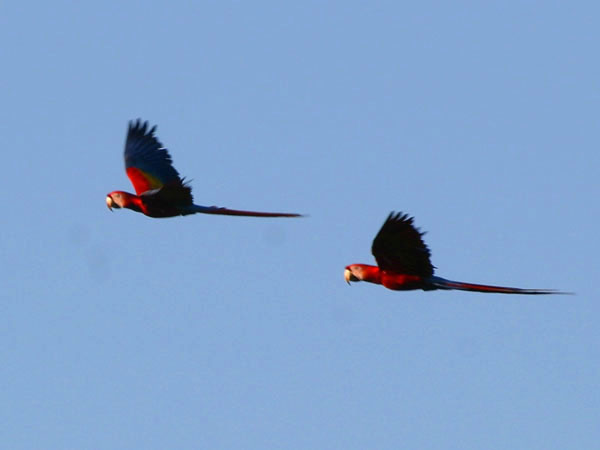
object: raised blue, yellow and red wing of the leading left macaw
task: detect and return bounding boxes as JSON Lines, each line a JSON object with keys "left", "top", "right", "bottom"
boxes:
{"left": 124, "top": 119, "right": 183, "bottom": 195}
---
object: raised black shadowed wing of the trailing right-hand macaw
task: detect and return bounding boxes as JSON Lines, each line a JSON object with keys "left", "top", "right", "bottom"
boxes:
{"left": 371, "top": 211, "right": 434, "bottom": 277}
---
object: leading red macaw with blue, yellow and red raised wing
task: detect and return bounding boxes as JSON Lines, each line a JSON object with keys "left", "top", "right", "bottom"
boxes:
{"left": 106, "top": 119, "right": 301, "bottom": 217}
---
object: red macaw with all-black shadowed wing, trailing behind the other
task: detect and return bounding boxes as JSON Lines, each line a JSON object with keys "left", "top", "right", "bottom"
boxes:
{"left": 344, "top": 212, "right": 566, "bottom": 294}
